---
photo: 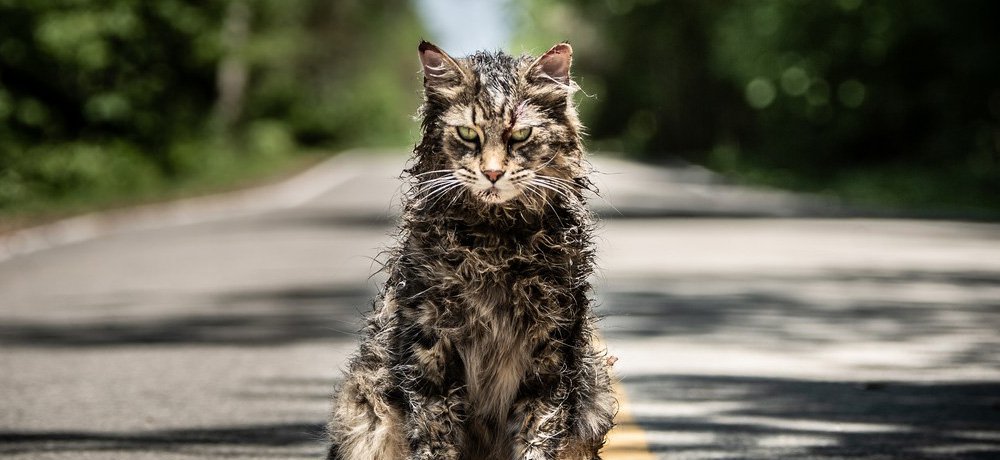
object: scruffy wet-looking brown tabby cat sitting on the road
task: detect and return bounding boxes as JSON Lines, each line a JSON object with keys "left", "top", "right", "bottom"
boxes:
{"left": 327, "top": 42, "right": 617, "bottom": 460}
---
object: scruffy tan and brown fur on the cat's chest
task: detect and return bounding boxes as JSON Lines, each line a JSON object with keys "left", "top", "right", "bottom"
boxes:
{"left": 406, "top": 228, "right": 571, "bottom": 420}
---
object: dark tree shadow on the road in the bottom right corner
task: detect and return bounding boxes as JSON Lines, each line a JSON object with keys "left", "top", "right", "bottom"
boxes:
{"left": 625, "top": 375, "right": 1000, "bottom": 460}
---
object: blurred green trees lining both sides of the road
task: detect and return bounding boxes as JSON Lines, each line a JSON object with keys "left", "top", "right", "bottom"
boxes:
{"left": 0, "top": 0, "right": 1000, "bottom": 222}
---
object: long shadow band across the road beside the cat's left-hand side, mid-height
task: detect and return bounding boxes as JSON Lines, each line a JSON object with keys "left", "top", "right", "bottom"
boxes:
{"left": 0, "top": 286, "right": 375, "bottom": 347}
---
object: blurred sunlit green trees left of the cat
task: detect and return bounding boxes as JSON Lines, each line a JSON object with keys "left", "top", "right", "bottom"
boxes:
{"left": 0, "top": 0, "right": 422, "bottom": 223}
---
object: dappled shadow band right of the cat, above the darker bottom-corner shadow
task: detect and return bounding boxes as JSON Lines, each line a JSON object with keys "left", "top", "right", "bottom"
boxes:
{"left": 598, "top": 271, "right": 1000, "bottom": 368}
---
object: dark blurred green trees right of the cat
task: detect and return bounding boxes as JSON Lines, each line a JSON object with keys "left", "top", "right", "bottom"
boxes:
{"left": 518, "top": 0, "right": 1000, "bottom": 216}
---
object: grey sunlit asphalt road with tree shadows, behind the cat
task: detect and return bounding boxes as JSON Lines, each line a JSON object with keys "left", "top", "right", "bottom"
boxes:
{"left": 0, "top": 152, "right": 1000, "bottom": 459}
